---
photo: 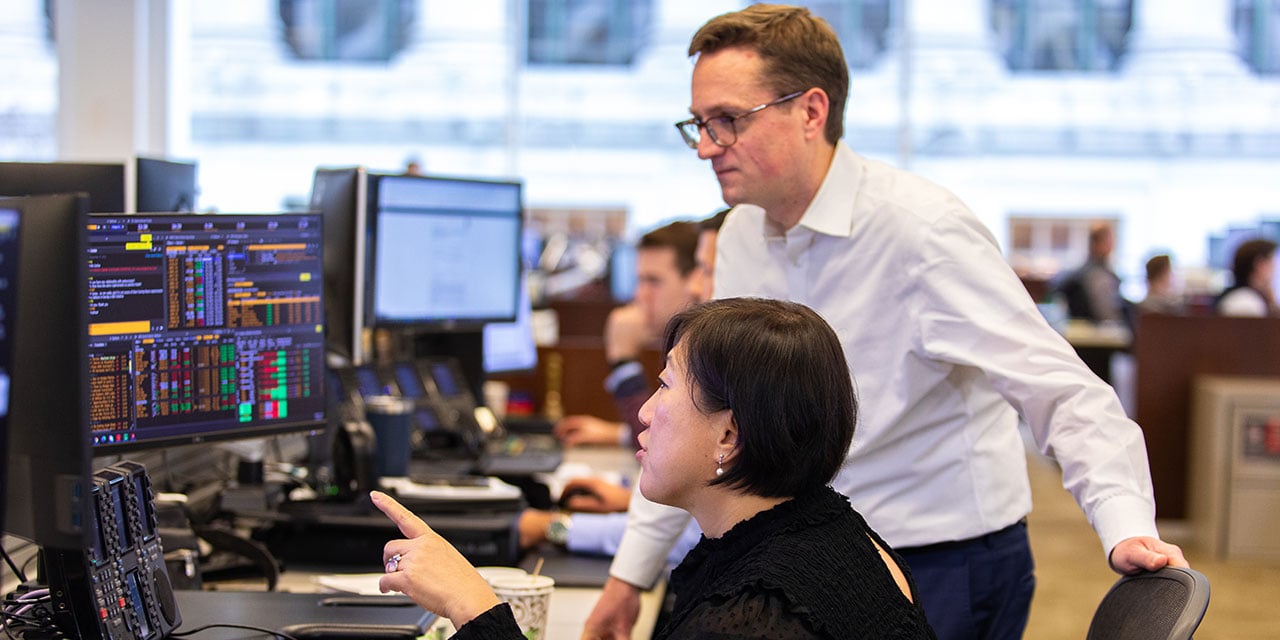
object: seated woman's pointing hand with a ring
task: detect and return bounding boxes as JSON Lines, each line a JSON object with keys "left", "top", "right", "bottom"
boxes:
{"left": 370, "top": 492, "right": 500, "bottom": 628}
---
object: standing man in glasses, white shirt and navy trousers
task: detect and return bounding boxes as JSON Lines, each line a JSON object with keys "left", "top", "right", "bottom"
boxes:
{"left": 584, "top": 5, "right": 1187, "bottom": 639}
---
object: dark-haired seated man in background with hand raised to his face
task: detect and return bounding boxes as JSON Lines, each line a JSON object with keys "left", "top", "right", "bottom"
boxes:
{"left": 556, "top": 220, "right": 698, "bottom": 447}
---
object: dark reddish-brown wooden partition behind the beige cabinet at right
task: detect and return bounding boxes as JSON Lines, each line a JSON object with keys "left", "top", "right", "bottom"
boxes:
{"left": 1134, "top": 315, "right": 1280, "bottom": 518}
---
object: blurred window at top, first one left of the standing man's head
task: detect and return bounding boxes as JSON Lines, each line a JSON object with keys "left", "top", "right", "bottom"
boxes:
{"left": 526, "top": 0, "right": 653, "bottom": 65}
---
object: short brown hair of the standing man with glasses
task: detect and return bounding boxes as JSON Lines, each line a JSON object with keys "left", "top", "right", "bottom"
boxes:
{"left": 689, "top": 4, "right": 849, "bottom": 145}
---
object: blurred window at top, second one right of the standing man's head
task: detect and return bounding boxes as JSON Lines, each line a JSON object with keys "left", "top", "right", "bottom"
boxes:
{"left": 991, "top": 0, "right": 1133, "bottom": 72}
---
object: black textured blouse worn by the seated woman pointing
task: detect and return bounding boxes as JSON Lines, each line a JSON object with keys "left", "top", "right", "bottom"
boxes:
{"left": 453, "top": 486, "right": 934, "bottom": 640}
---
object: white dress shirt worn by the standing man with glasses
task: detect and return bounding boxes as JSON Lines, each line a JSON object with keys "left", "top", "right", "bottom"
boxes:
{"left": 611, "top": 142, "right": 1157, "bottom": 585}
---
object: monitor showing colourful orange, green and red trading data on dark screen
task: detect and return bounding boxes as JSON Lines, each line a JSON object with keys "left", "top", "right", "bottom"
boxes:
{"left": 83, "top": 214, "right": 326, "bottom": 456}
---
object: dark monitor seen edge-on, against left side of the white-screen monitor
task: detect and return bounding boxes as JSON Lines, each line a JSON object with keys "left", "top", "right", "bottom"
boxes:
{"left": 311, "top": 166, "right": 367, "bottom": 365}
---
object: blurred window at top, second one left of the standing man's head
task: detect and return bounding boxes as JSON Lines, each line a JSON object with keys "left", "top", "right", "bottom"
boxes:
{"left": 279, "top": 0, "right": 416, "bottom": 61}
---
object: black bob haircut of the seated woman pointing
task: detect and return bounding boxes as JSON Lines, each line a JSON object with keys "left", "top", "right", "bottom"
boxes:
{"left": 664, "top": 298, "right": 858, "bottom": 498}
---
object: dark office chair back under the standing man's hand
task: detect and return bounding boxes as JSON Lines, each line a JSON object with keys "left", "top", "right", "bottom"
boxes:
{"left": 1087, "top": 567, "right": 1208, "bottom": 640}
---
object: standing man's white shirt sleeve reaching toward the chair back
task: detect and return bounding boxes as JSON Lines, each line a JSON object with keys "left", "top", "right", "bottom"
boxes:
{"left": 906, "top": 215, "right": 1157, "bottom": 554}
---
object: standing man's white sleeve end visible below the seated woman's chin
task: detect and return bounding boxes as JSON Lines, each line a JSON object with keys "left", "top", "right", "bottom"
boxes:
{"left": 609, "top": 477, "right": 691, "bottom": 589}
